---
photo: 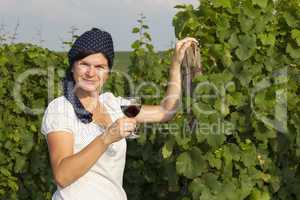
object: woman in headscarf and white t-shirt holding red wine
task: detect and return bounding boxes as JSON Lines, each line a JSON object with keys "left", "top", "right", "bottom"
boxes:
{"left": 41, "top": 28, "right": 198, "bottom": 200}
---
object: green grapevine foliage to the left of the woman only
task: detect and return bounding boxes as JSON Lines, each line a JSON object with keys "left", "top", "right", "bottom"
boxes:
{"left": 0, "top": 44, "right": 66, "bottom": 199}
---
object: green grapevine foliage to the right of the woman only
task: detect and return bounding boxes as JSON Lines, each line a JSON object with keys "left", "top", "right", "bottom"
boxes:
{"left": 125, "top": 0, "right": 300, "bottom": 200}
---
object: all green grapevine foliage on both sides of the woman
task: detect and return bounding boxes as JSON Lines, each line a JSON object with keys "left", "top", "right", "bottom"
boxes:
{"left": 0, "top": 0, "right": 300, "bottom": 200}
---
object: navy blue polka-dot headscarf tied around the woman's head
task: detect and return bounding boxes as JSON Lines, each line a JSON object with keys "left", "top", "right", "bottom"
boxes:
{"left": 63, "top": 28, "right": 114, "bottom": 124}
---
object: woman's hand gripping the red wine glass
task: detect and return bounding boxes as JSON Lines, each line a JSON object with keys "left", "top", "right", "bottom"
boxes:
{"left": 103, "top": 117, "right": 137, "bottom": 145}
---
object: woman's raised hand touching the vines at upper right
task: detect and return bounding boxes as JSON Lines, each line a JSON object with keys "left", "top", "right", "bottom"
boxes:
{"left": 172, "top": 37, "right": 199, "bottom": 65}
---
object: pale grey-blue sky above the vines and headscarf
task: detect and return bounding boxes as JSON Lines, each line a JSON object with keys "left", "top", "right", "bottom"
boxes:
{"left": 0, "top": 0, "right": 200, "bottom": 51}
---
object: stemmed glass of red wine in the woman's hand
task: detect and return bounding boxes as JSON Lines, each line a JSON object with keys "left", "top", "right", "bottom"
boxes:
{"left": 120, "top": 97, "right": 142, "bottom": 139}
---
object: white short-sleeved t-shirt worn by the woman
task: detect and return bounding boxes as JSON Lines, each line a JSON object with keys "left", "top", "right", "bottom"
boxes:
{"left": 41, "top": 92, "right": 127, "bottom": 200}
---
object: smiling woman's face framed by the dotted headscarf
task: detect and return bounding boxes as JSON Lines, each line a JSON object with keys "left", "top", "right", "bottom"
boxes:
{"left": 73, "top": 53, "right": 109, "bottom": 92}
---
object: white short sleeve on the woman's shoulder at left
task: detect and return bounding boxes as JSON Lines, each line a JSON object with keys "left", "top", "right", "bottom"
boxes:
{"left": 41, "top": 97, "right": 75, "bottom": 135}
